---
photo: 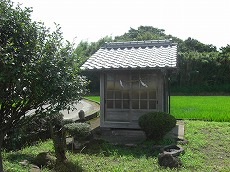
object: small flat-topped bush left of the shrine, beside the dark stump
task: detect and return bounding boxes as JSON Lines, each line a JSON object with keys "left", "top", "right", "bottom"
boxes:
{"left": 64, "top": 123, "right": 91, "bottom": 141}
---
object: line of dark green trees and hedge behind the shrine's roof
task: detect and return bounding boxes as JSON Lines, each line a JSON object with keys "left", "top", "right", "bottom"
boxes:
{"left": 76, "top": 26, "right": 230, "bottom": 92}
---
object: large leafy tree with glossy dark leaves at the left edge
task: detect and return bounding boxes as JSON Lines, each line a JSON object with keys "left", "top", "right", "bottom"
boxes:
{"left": 0, "top": 0, "right": 87, "bottom": 171}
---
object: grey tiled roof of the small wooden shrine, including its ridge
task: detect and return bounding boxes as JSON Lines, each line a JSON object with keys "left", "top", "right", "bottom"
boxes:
{"left": 81, "top": 40, "right": 177, "bottom": 70}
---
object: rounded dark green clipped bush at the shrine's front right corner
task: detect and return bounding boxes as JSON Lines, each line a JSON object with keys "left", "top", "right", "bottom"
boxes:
{"left": 138, "top": 112, "right": 176, "bottom": 140}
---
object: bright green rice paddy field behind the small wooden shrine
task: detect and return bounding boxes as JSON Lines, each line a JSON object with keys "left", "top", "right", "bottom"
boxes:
{"left": 86, "top": 96, "right": 230, "bottom": 122}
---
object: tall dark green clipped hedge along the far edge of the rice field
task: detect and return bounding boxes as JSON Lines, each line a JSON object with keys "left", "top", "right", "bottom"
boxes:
{"left": 172, "top": 52, "right": 230, "bottom": 92}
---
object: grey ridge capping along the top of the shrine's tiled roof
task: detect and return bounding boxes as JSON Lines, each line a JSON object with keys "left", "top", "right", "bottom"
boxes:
{"left": 101, "top": 39, "right": 176, "bottom": 49}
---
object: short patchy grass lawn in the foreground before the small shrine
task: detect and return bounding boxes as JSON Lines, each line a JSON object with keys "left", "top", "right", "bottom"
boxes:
{"left": 3, "top": 120, "right": 230, "bottom": 172}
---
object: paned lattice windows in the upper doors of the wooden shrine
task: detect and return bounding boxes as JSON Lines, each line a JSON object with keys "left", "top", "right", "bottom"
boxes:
{"left": 106, "top": 72, "right": 157, "bottom": 110}
